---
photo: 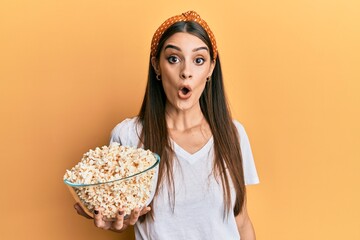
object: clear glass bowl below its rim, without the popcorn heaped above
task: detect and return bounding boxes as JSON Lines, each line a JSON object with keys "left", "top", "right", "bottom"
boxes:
{"left": 64, "top": 154, "right": 160, "bottom": 219}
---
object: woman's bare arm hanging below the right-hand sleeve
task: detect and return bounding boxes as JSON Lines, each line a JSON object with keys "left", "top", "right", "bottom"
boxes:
{"left": 235, "top": 200, "right": 256, "bottom": 240}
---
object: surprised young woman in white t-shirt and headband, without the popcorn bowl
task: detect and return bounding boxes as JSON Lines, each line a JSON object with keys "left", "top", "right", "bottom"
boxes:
{"left": 75, "top": 11, "right": 258, "bottom": 240}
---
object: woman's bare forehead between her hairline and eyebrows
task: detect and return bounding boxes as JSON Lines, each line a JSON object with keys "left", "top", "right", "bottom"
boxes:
{"left": 164, "top": 32, "right": 206, "bottom": 49}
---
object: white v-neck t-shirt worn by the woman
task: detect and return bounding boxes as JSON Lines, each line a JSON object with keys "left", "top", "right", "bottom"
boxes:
{"left": 110, "top": 118, "right": 259, "bottom": 240}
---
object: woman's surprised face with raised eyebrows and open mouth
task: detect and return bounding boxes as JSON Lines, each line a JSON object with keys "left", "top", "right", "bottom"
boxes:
{"left": 152, "top": 32, "right": 215, "bottom": 111}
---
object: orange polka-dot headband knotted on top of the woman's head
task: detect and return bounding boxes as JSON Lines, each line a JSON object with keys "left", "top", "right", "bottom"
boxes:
{"left": 151, "top": 11, "right": 217, "bottom": 60}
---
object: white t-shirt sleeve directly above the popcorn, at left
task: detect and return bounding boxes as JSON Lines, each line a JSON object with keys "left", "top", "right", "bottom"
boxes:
{"left": 110, "top": 118, "right": 140, "bottom": 147}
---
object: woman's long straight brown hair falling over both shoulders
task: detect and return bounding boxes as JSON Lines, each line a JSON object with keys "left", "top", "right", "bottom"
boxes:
{"left": 138, "top": 21, "right": 246, "bottom": 217}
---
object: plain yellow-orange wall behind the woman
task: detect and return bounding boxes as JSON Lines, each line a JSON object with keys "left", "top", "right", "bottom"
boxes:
{"left": 0, "top": 0, "right": 360, "bottom": 240}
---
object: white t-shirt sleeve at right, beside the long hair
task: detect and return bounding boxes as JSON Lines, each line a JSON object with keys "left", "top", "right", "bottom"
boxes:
{"left": 234, "top": 120, "right": 259, "bottom": 185}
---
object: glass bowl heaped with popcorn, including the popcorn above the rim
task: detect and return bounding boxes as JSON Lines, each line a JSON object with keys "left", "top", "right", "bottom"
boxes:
{"left": 64, "top": 143, "right": 160, "bottom": 219}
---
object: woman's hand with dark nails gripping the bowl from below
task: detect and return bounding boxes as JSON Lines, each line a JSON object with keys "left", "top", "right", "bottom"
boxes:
{"left": 74, "top": 203, "right": 151, "bottom": 232}
